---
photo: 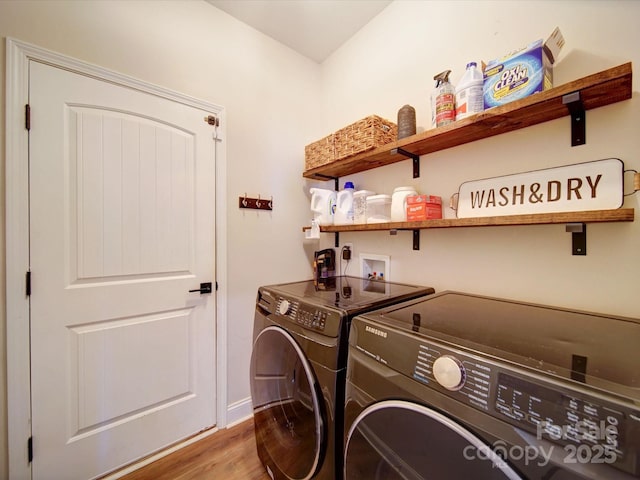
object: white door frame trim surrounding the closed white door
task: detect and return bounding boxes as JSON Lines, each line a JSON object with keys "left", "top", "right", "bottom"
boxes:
{"left": 5, "top": 38, "right": 227, "bottom": 480}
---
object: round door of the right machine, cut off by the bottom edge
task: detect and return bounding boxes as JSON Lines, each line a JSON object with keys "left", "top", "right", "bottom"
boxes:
{"left": 344, "top": 400, "right": 522, "bottom": 480}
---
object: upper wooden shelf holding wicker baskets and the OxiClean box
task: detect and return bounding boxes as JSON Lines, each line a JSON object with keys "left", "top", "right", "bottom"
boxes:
{"left": 302, "top": 63, "right": 632, "bottom": 180}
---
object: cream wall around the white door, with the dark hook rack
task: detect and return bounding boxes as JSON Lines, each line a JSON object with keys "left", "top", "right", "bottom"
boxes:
{"left": 0, "top": 0, "right": 320, "bottom": 472}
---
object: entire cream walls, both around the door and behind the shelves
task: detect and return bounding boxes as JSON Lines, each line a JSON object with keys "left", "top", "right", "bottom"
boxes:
{"left": 0, "top": 0, "right": 640, "bottom": 477}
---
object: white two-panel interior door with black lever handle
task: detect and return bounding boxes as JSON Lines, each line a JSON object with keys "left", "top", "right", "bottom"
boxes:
{"left": 29, "top": 61, "right": 216, "bottom": 480}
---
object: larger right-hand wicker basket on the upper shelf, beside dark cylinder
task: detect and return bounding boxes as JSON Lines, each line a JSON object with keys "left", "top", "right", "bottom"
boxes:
{"left": 335, "top": 115, "right": 398, "bottom": 160}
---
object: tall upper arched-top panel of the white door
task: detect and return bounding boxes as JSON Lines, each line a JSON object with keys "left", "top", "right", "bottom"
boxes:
{"left": 67, "top": 107, "right": 195, "bottom": 280}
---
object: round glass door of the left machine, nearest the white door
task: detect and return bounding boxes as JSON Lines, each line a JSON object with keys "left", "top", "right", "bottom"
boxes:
{"left": 251, "top": 326, "right": 325, "bottom": 480}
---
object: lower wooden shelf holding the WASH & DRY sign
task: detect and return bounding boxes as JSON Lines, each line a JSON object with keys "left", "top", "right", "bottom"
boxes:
{"left": 303, "top": 208, "right": 634, "bottom": 233}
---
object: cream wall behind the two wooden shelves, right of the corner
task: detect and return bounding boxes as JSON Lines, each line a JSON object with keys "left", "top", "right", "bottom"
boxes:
{"left": 318, "top": 0, "right": 640, "bottom": 317}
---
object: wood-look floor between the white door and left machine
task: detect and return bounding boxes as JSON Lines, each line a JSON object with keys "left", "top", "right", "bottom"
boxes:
{"left": 121, "top": 420, "right": 271, "bottom": 480}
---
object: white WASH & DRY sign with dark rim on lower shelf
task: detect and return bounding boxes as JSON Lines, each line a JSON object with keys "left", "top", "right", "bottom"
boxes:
{"left": 457, "top": 158, "right": 624, "bottom": 218}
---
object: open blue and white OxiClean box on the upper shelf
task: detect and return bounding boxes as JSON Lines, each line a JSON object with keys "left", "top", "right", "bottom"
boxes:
{"left": 483, "top": 27, "right": 564, "bottom": 110}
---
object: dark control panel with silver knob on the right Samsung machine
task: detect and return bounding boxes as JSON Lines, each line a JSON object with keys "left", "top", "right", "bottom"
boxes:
{"left": 350, "top": 317, "right": 640, "bottom": 475}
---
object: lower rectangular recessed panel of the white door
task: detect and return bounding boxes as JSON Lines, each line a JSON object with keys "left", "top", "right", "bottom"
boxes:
{"left": 69, "top": 310, "right": 195, "bottom": 440}
